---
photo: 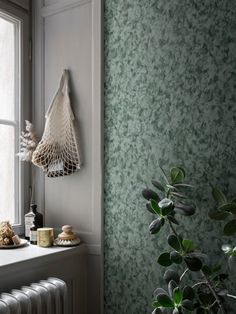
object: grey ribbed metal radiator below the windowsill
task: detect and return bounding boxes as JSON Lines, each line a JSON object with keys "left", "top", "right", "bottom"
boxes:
{"left": 0, "top": 277, "right": 68, "bottom": 314}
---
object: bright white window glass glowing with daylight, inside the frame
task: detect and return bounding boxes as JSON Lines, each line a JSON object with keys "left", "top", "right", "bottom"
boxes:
{"left": 0, "top": 16, "right": 17, "bottom": 223}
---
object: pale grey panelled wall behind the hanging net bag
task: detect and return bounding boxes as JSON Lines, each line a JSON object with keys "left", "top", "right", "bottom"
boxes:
{"left": 33, "top": 0, "right": 102, "bottom": 314}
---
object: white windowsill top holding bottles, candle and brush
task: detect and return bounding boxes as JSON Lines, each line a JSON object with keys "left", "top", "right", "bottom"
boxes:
{"left": 0, "top": 244, "right": 84, "bottom": 270}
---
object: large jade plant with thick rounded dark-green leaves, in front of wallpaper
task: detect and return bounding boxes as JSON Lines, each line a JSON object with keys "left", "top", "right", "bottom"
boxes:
{"left": 142, "top": 167, "right": 235, "bottom": 314}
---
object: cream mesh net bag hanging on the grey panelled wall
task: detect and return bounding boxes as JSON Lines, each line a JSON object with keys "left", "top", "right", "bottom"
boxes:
{"left": 32, "top": 70, "right": 80, "bottom": 177}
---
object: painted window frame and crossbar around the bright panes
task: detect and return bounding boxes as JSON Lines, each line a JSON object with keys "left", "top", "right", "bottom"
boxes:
{"left": 0, "top": 0, "right": 31, "bottom": 234}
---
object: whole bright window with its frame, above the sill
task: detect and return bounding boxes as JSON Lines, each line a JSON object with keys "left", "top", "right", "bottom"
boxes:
{"left": 0, "top": 1, "right": 29, "bottom": 232}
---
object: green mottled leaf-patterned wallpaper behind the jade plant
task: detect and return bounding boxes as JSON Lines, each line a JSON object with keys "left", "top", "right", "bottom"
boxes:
{"left": 104, "top": 0, "right": 236, "bottom": 314}
